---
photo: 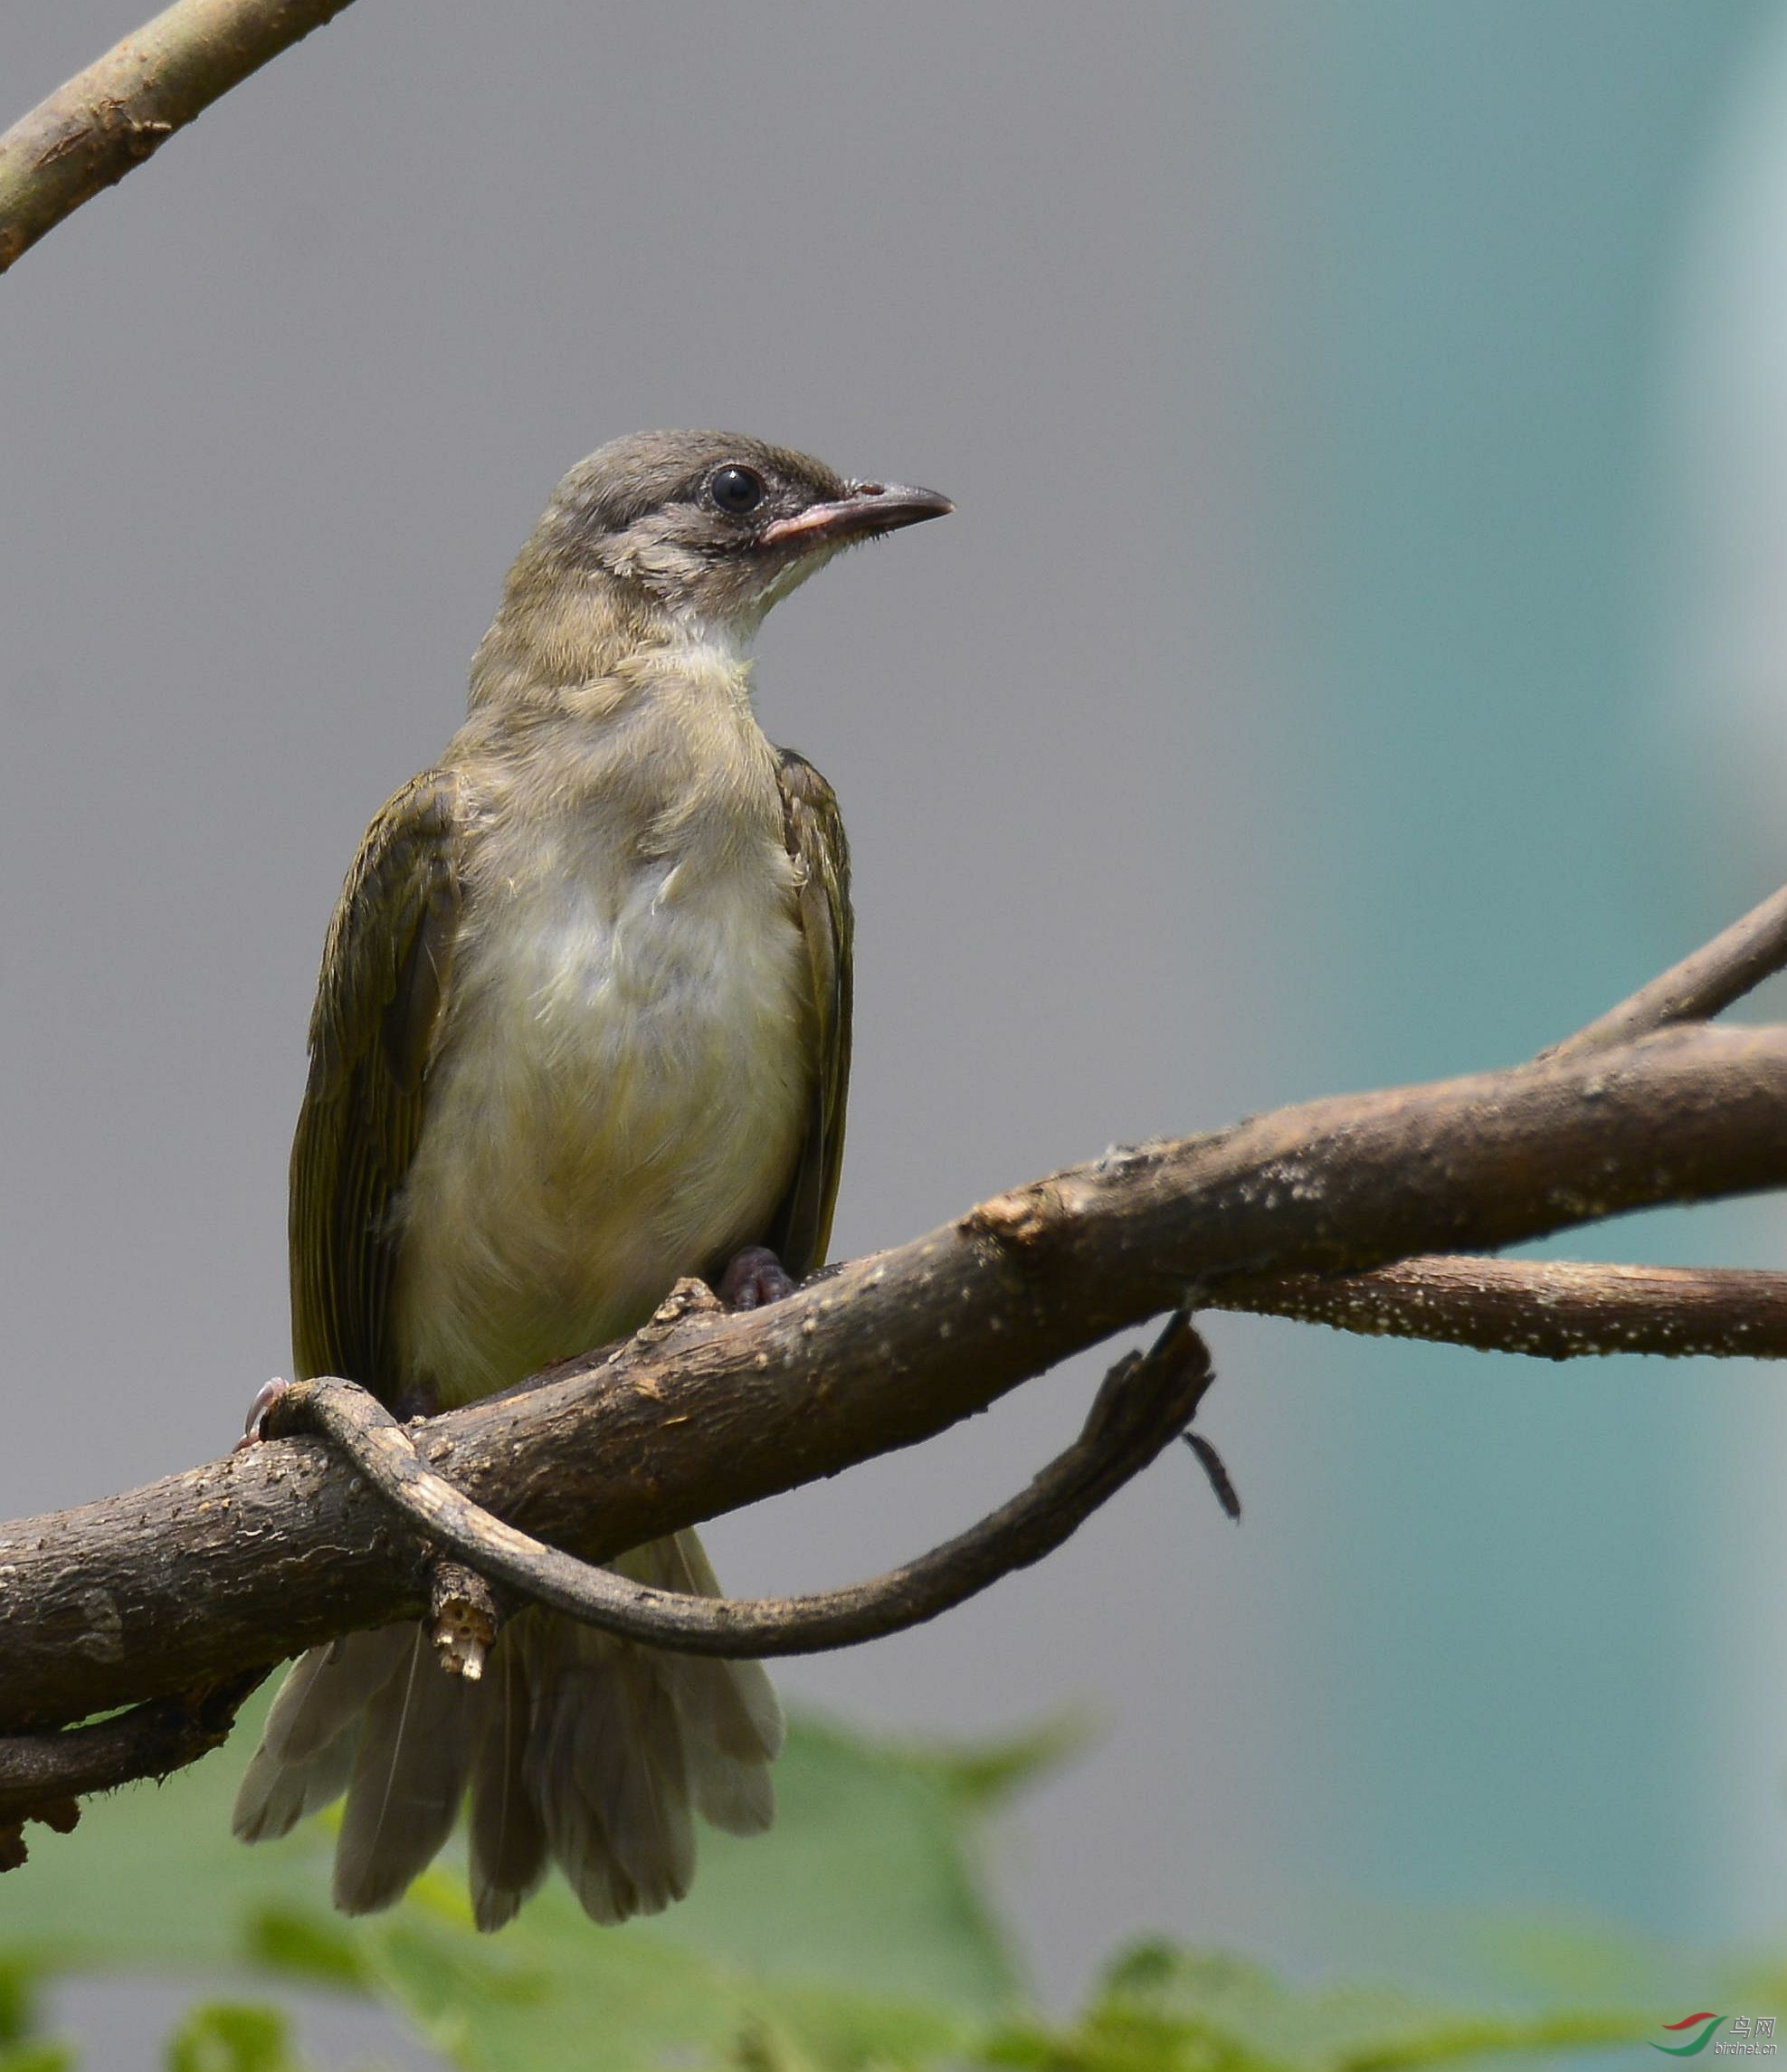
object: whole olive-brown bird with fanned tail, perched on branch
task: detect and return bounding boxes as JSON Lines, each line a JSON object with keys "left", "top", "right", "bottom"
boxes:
{"left": 233, "top": 431, "right": 954, "bottom": 1929}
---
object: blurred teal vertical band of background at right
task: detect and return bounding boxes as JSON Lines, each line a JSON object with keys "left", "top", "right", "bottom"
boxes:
{"left": 1248, "top": 0, "right": 1787, "bottom": 1964}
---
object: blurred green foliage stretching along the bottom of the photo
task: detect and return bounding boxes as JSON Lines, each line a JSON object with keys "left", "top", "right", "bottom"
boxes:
{"left": 0, "top": 1720, "right": 1725, "bottom": 2072}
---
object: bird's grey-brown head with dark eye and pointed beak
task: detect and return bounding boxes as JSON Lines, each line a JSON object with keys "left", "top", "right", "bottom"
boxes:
{"left": 535, "top": 431, "right": 954, "bottom": 636}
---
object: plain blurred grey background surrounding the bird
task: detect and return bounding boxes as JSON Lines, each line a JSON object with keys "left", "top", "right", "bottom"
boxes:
{"left": 0, "top": 0, "right": 1286, "bottom": 2062}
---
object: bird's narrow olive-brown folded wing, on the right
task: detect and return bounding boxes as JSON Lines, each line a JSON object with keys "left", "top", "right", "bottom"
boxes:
{"left": 765, "top": 748, "right": 852, "bottom": 1278}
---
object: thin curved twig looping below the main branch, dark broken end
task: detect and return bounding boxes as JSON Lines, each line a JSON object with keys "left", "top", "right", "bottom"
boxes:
{"left": 268, "top": 1312, "right": 1215, "bottom": 1656}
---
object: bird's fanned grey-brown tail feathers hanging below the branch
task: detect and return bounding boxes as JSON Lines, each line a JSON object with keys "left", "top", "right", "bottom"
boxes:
{"left": 233, "top": 1534, "right": 782, "bottom": 1929}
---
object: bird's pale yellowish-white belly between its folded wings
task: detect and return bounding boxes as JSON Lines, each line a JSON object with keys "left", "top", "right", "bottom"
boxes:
{"left": 394, "top": 853, "right": 814, "bottom": 1402}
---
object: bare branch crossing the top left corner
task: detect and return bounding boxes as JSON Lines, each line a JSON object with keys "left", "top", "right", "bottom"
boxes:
{"left": 0, "top": 0, "right": 350, "bottom": 273}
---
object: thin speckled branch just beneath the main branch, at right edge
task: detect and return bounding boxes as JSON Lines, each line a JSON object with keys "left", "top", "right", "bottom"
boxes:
{"left": 1209, "top": 1256, "right": 1787, "bottom": 1359}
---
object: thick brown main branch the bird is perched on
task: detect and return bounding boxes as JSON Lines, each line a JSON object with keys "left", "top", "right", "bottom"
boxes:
{"left": 0, "top": 1028, "right": 1787, "bottom": 1730}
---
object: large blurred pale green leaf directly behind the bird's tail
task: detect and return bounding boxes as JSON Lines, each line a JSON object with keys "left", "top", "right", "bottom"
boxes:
{"left": 0, "top": 1690, "right": 1013, "bottom": 2072}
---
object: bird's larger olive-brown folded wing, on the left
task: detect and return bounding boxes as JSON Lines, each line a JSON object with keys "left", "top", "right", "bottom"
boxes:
{"left": 290, "top": 771, "right": 464, "bottom": 1401}
